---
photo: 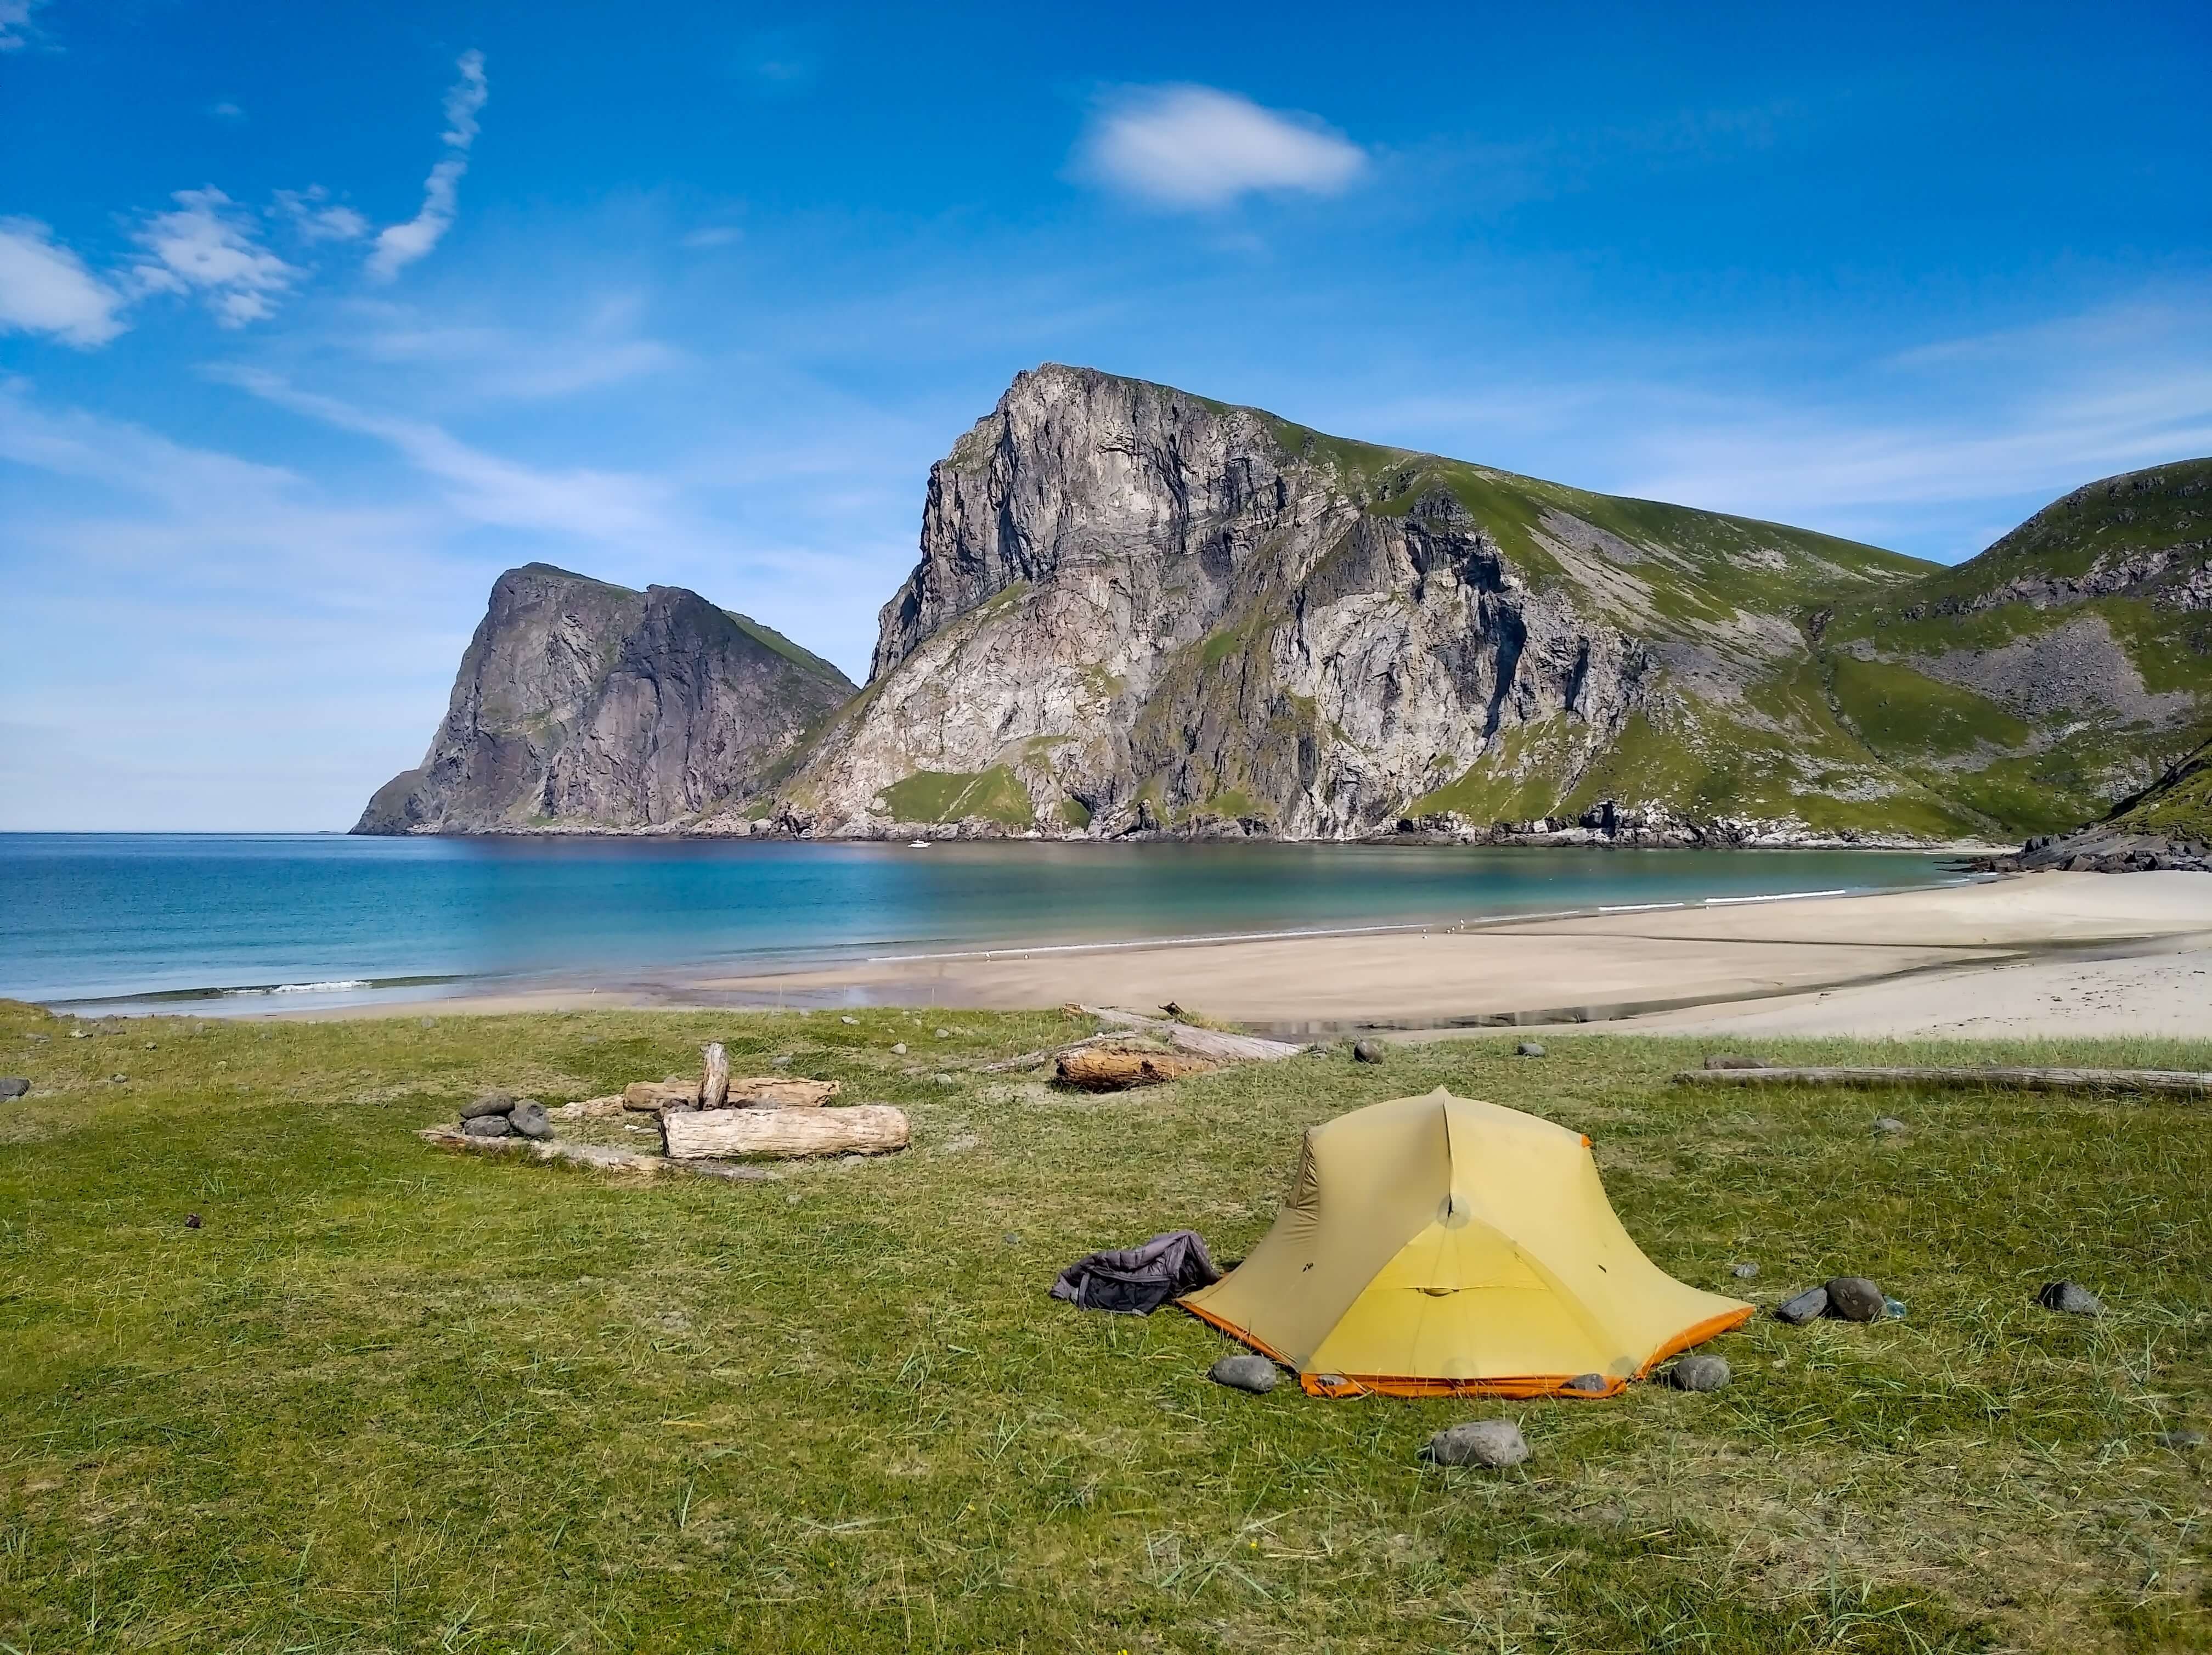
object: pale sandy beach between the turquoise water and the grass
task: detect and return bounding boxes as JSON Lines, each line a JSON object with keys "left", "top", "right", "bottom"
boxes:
{"left": 290, "top": 874, "right": 2212, "bottom": 1038}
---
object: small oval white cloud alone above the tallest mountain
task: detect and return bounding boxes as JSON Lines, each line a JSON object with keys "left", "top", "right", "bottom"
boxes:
{"left": 1077, "top": 86, "right": 1367, "bottom": 208}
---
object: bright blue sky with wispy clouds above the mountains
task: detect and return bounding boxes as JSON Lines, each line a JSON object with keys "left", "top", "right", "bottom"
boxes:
{"left": 0, "top": 0, "right": 2212, "bottom": 830}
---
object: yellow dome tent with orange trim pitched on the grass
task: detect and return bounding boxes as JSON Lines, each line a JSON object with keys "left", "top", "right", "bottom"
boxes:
{"left": 1181, "top": 1087, "right": 1752, "bottom": 1396}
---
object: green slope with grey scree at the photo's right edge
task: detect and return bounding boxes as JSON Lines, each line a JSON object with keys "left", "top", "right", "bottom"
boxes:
{"left": 1814, "top": 460, "right": 2212, "bottom": 832}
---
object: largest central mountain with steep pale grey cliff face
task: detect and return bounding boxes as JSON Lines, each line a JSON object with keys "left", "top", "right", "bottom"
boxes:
{"left": 783, "top": 367, "right": 1957, "bottom": 836}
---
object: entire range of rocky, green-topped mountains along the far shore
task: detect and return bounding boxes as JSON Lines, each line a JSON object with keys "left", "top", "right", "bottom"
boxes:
{"left": 360, "top": 365, "right": 2212, "bottom": 843}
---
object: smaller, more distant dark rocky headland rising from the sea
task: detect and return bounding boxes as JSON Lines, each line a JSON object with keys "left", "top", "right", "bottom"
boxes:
{"left": 354, "top": 564, "right": 854, "bottom": 834}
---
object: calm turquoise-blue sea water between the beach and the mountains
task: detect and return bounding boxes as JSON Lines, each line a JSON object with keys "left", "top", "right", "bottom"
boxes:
{"left": 0, "top": 834, "right": 1953, "bottom": 1011}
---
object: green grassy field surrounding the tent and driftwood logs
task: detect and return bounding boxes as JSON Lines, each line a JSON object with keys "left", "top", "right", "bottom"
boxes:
{"left": 0, "top": 1005, "right": 2212, "bottom": 1655}
